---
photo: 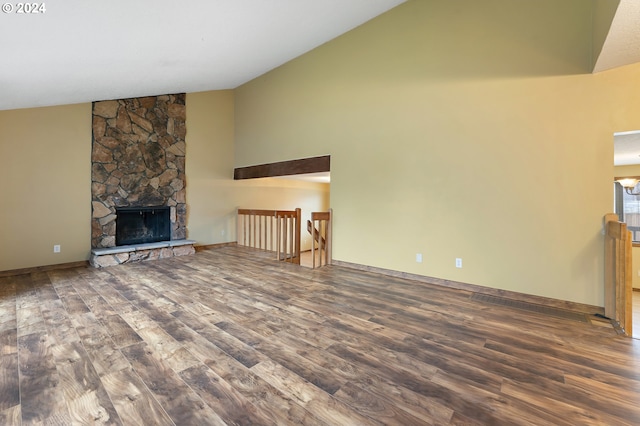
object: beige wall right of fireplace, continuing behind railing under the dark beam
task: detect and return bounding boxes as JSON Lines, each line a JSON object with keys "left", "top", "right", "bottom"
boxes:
{"left": 186, "top": 91, "right": 329, "bottom": 250}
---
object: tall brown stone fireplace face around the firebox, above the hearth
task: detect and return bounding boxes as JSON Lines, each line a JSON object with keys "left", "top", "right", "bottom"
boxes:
{"left": 91, "top": 93, "right": 194, "bottom": 263}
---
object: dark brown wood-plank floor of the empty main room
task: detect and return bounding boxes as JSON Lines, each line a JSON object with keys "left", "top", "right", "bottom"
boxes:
{"left": 0, "top": 246, "right": 640, "bottom": 425}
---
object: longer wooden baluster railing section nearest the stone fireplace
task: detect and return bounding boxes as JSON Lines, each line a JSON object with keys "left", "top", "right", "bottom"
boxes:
{"left": 238, "top": 209, "right": 301, "bottom": 265}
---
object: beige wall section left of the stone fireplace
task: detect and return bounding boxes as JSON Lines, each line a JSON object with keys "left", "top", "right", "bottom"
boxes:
{"left": 0, "top": 104, "right": 91, "bottom": 271}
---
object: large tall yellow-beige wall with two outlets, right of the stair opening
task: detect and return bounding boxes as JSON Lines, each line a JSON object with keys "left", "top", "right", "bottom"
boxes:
{"left": 235, "top": 0, "right": 640, "bottom": 306}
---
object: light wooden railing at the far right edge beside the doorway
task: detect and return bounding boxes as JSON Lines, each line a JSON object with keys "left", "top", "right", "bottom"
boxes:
{"left": 604, "top": 213, "right": 633, "bottom": 336}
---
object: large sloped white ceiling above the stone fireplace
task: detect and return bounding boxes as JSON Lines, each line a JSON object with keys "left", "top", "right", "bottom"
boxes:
{"left": 0, "top": 0, "right": 405, "bottom": 110}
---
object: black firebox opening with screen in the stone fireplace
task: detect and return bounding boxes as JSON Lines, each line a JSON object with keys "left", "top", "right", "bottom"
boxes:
{"left": 116, "top": 207, "right": 171, "bottom": 246}
